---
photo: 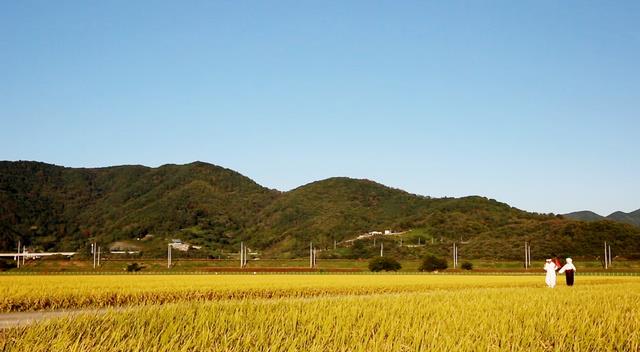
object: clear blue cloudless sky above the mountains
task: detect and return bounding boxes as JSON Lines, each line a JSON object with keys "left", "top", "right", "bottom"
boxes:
{"left": 0, "top": 0, "right": 640, "bottom": 215}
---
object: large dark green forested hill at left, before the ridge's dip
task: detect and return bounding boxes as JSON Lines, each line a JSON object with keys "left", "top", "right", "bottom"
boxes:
{"left": 0, "top": 162, "right": 279, "bottom": 254}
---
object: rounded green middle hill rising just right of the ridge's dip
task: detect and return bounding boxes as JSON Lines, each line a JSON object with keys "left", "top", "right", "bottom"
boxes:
{"left": 245, "top": 177, "right": 432, "bottom": 252}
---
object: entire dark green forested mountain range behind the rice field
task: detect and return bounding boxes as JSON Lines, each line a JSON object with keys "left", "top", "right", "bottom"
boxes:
{"left": 0, "top": 161, "right": 640, "bottom": 258}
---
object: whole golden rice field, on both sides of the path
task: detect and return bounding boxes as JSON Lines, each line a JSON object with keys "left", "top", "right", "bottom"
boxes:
{"left": 0, "top": 275, "right": 640, "bottom": 351}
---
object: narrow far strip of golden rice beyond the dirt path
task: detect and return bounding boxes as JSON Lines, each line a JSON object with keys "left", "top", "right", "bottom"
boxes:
{"left": 0, "top": 275, "right": 576, "bottom": 312}
